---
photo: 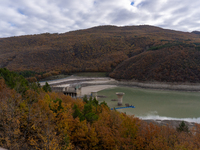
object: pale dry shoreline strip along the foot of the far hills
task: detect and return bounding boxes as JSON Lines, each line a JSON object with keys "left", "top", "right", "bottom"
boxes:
{"left": 40, "top": 76, "right": 200, "bottom": 91}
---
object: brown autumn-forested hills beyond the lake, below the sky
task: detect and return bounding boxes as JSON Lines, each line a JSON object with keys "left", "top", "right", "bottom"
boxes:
{"left": 0, "top": 25, "right": 200, "bottom": 82}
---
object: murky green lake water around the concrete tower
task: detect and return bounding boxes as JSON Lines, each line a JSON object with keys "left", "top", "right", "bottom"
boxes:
{"left": 98, "top": 87, "right": 200, "bottom": 122}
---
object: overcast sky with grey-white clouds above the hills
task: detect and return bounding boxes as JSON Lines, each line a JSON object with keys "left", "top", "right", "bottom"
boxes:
{"left": 0, "top": 0, "right": 200, "bottom": 37}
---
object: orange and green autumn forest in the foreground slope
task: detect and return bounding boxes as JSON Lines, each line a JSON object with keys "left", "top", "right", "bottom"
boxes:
{"left": 0, "top": 68, "right": 200, "bottom": 150}
